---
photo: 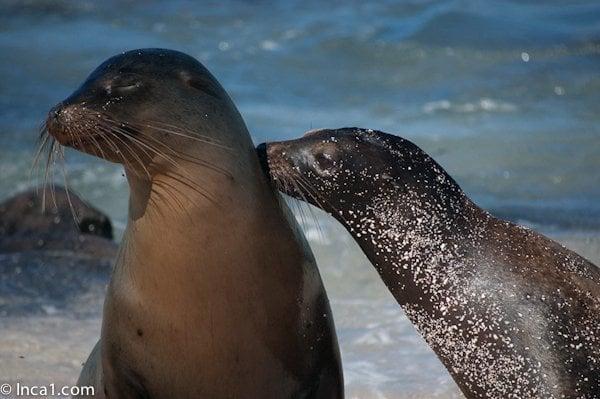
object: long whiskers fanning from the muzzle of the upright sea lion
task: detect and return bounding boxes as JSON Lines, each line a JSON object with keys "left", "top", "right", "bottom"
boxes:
{"left": 31, "top": 107, "right": 233, "bottom": 221}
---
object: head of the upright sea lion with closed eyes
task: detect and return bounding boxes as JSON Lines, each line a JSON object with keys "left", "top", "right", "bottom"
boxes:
{"left": 45, "top": 49, "right": 243, "bottom": 176}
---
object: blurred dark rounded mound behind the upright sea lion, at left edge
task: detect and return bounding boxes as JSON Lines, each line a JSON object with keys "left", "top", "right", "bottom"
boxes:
{"left": 0, "top": 186, "right": 117, "bottom": 318}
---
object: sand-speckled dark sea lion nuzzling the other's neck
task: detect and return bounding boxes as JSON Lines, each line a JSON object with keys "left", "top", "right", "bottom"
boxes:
{"left": 259, "top": 128, "right": 600, "bottom": 398}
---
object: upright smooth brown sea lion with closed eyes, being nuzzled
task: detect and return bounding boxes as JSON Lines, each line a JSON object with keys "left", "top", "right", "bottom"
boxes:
{"left": 47, "top": 49, "right": 343, "bottom": 398}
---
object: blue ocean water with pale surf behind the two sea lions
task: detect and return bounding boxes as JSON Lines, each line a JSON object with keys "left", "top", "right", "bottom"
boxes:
{"left": 0, "top": 0, "right": 600, "bottom": 397}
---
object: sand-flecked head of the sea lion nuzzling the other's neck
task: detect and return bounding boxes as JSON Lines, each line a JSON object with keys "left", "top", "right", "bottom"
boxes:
{"left": 258, "top": 128, "right": 393, "bottom": 213}
